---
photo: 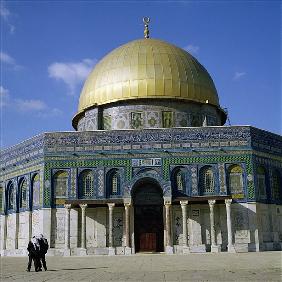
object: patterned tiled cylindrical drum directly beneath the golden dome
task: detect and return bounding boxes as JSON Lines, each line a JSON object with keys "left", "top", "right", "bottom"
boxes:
{"left": 73, "top": 99, "right": 226, "bottom": 131}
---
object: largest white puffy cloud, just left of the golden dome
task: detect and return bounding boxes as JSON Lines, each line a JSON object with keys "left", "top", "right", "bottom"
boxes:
{"left": 48, "top": 59, "right": 96, "bottom": 95}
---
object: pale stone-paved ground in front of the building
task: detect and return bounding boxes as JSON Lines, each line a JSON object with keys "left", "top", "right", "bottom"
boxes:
{"left": 0, "top": 252, "right": 282, "bottom": 282}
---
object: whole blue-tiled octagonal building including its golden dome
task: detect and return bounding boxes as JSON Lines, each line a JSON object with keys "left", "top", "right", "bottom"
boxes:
{"left": 0, "top": 25, "right": 282, "bottom": 256}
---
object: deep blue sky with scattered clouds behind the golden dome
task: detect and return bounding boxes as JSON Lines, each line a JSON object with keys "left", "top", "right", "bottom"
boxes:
{"left": 0, "top": 0, "right": 282, "bottom": 148}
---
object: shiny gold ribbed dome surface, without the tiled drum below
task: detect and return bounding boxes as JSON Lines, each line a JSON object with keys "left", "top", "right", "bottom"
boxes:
{"left": 78, "top": 39, "right": 219, "bottom": 113}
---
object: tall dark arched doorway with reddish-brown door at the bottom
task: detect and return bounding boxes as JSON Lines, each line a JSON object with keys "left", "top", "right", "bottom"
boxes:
{"left": 132, "top": 179, "right": 164, "bottom": 252}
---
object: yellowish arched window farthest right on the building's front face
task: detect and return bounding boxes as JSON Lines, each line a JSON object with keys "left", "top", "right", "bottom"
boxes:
{"left": 228, "top": 165, "right": 244, "bottom": 196}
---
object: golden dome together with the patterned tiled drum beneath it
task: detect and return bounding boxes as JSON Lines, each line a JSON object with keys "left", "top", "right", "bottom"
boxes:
{"left": 72, "top": 39, "right": 226, "bottom": 131}
